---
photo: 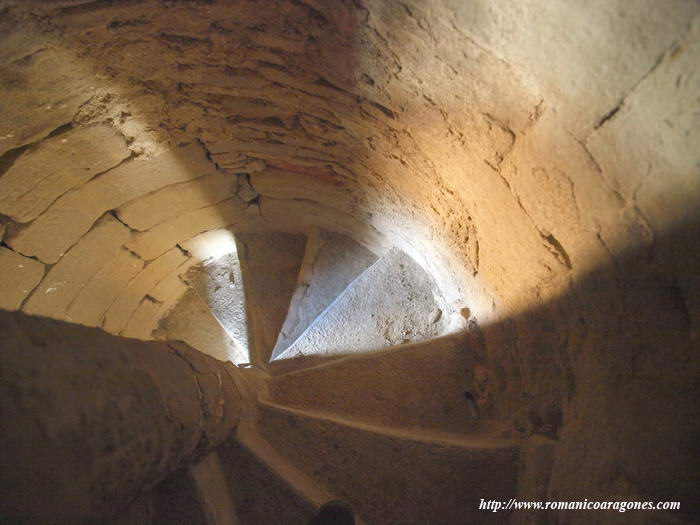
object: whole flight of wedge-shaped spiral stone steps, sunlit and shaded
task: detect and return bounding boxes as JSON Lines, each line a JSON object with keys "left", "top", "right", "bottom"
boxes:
{"left": 153, "top": 232, "right": 518, "bottom": 525}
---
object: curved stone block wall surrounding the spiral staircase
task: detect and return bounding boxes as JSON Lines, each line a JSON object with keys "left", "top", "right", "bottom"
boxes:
{"left": 0, "top": 0, "right": 700, "bottom": 521}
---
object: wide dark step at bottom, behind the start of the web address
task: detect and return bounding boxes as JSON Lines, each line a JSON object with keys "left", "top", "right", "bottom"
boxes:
{"left": 259, "top": 403, "right": 518, "bottom": 525}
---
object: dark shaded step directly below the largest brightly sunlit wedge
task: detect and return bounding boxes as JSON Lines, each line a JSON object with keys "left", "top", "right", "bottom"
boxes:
{"left": 268, "top": 334, "right": 480, "bottom": 433}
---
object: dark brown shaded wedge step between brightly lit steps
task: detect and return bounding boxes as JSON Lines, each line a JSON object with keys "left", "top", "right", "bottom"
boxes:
{"left": 236, "top": 233, "right": 306, "bottom": 367}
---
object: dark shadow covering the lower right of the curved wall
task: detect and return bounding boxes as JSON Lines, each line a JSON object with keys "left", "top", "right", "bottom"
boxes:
{"left": 473, "top": 215, "right": 700, "bottom": 523}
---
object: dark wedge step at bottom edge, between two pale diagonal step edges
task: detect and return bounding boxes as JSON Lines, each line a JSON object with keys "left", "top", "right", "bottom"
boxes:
{"left": 217, "top": 433, "right": 334, "bottom": 525}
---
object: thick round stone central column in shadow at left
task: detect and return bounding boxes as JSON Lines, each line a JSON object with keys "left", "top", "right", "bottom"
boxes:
{"left": 0, "top": 310, "right": 241, "bottom": 523}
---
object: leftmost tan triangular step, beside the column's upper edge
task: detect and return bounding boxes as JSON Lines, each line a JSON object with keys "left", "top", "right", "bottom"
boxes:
{"left": 154, "top": 288, "right": 248, "bottom": 364}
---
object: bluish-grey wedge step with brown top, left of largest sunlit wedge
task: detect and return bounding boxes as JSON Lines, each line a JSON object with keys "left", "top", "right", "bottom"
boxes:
{"left": 272, "top": 232, "right": 377, "bottom": 359}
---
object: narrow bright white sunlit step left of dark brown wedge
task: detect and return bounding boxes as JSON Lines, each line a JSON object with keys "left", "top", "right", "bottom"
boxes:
{"left": 185, "top": 252, "right": 250, "bottom": 364}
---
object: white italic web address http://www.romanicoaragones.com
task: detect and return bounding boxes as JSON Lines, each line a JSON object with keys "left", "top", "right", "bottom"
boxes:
{"left": 479, "top": 498, "right": 681, "bottom": 512}
